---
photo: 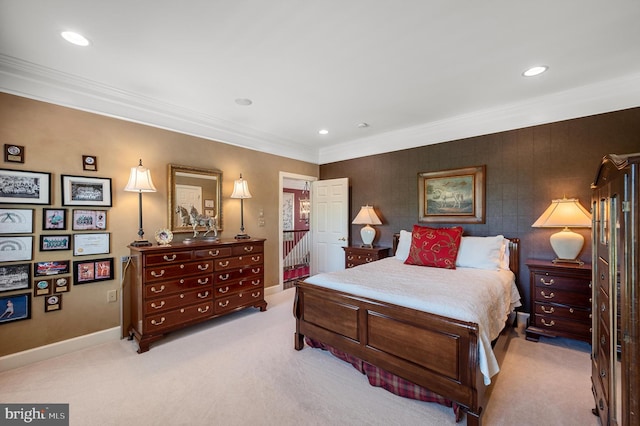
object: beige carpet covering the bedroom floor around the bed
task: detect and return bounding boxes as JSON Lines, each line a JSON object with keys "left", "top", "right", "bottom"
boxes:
{"left": 0, "top": 290, "right": 598, "bottom": 426}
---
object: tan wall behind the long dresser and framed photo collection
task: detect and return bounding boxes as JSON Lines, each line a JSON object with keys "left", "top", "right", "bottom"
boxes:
{"left": 0, "top": 94, "right": 319, "bottom": 356}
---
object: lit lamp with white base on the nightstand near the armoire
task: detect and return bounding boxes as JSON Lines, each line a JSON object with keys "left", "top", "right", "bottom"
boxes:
{"left": 531, "top": 197, "right": 591, "bottom": 265}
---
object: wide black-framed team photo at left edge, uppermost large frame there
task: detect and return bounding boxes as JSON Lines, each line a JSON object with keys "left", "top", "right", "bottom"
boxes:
{"left": 0, "top": 169, "right": 51, "bottom": 205}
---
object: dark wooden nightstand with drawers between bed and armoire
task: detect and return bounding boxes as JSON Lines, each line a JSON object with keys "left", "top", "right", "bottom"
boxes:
{"left": 526, "top": 259, "right": 592, "bottom": 343}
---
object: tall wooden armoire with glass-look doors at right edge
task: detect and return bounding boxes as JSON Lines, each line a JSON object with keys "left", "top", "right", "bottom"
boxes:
{"left": 591, "top": 153, "right": 640, "bottom": 426}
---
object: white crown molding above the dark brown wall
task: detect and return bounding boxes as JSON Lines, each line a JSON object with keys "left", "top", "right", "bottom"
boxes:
{"left": 318, "top": 73, "right": 640, "bottom": 164}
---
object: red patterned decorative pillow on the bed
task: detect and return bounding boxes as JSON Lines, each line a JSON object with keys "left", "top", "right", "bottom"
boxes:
{"left": 404, "top": 225, "right": 462, "bottom": 269}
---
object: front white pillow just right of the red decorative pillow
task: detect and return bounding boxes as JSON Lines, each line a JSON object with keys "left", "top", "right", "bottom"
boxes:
{"left": 456, "top": 235, "right": 504, "bottom": 270}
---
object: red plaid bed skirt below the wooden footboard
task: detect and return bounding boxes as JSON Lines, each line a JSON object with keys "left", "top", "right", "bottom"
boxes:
{"left": 304, "top": 337, "right": 463, "bottom": 422}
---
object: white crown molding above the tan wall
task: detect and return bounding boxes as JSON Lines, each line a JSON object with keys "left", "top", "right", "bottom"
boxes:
{"left": 0, "top": 54, "right": 318, "bottom": 164}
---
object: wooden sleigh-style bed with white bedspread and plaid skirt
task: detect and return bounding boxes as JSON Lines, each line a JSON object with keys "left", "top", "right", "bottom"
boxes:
{"left": 293, "top": 231, "right": 520, "bottom": 425}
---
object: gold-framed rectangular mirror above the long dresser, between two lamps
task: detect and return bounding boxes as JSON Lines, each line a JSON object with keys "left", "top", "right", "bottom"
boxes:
{"left": 167, "top": 164, "right": 222, "bottom": 233}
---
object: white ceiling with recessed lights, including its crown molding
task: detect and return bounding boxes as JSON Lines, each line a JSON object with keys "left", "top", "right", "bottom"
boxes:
{"left": 0, "top": 0, "right": 640, "bottom": 164}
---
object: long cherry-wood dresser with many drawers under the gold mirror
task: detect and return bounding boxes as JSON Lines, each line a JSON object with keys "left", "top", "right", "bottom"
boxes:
{"left": 125, "top": 239, "right": 267, "bottom": 353}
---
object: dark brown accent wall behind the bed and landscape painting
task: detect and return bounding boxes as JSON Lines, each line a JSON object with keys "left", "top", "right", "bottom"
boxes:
{"left": 320, "top": 108, "right": 640, "bottom": 311}
